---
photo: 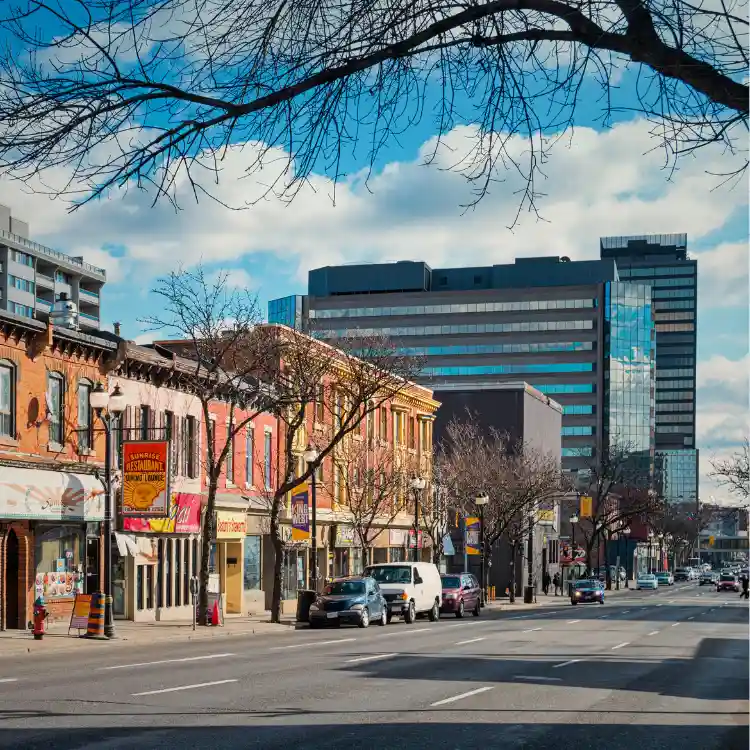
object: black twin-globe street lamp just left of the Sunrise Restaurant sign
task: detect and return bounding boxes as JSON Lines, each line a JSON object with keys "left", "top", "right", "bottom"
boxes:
{"left": 89, "top": 383, "right": 128, "bottom": 638}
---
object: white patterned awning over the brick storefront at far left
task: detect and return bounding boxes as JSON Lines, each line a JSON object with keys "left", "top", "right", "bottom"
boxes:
{"left": 0, "top": 466, "right": 104, "bottom": 522}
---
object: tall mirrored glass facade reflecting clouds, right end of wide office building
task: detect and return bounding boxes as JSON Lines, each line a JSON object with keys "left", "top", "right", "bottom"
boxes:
{"left": 604, "top": 282, "right": 655, "bottom": 453}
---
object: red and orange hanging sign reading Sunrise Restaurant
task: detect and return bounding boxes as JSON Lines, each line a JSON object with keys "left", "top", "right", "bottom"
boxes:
{"left": 122, "top": 440, "right": 169, "bottom": 516}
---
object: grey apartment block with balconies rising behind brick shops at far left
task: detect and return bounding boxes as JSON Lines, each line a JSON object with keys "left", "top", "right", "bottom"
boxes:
{"left": 0, "top": 206, "right": 107, "bottom": 330}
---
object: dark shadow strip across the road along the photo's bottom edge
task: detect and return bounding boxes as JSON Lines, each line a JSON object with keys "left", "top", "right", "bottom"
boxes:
{"left": 0, "top": 714, "right": 749, "bottom": 750}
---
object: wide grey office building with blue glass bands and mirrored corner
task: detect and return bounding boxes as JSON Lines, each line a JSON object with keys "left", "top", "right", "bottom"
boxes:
{"left": 269, "top": 257, "right": 654, "bottom": 469}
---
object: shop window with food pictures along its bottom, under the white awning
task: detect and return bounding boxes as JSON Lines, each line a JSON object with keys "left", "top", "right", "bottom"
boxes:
{"left": 34, "top": 523, "right": 85, "bottom": 599}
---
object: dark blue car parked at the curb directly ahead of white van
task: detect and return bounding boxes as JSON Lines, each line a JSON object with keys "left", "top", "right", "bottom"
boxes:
{"left": 310, "top": 576, "right": 388, "bottom": 628}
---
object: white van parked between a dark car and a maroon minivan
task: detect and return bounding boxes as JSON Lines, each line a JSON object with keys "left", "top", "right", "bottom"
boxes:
{"left": 364, "top": 562, "right": 443, "bottom": 623}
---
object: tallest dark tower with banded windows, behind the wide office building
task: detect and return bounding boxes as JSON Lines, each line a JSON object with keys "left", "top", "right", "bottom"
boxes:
{"left": 600, "top": 234, "right": 698, "bottom": 505}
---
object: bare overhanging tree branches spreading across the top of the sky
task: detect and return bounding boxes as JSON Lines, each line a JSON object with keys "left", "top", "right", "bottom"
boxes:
{"left": 0, "top": 0, "right": 748, "bottom": 217}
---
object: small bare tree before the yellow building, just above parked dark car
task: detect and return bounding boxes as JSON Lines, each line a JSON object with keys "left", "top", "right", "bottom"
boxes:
{"left": 334, "top": 431, "right": 415, "bottom": 562}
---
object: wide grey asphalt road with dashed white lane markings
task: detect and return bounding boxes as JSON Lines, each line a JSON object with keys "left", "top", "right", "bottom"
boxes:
{"left": 0, "top": 584, "right": 749, "bottom": 750}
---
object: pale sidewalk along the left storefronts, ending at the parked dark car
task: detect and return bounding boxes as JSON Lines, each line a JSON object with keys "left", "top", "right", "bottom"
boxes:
{"left": 0, "top": 612, "right": 295, "bottom": 659}
